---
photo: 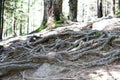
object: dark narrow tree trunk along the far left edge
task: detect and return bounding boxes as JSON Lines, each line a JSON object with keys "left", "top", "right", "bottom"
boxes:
{"left": 0, "top": 0, "right": 4, "bottom": 40}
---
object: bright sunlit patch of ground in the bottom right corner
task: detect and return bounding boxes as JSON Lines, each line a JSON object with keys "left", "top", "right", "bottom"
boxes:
{"left": 89, "top": 66, "right": 120, "bottom": 80}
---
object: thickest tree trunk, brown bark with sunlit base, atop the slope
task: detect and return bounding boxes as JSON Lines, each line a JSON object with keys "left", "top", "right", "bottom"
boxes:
{"left": 41, "top": 0, "right": 63, "bottom": 27}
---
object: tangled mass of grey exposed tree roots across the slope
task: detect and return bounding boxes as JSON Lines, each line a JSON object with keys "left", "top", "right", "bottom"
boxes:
{"left": 0, "top": 30, "right": 120, "bottom": 76}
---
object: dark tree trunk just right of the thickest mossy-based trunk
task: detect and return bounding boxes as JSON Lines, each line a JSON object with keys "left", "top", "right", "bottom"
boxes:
{"left": 68, "top": 0, "right": 78, "bottom": 22}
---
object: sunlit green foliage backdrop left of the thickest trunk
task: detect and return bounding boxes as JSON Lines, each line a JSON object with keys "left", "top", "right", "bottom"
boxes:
{"left": 3, "top": 0, "right": 43, "bottom": 37}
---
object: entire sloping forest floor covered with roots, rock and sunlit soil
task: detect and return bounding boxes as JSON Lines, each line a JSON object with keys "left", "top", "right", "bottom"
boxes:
{"left": 0, "top": 18, "right": 120, "bottom": 80}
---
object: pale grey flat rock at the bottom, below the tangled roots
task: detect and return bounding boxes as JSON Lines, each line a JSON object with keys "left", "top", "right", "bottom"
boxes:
{"left": 25, "top": 63, "right": 68, "bottom": 80}
